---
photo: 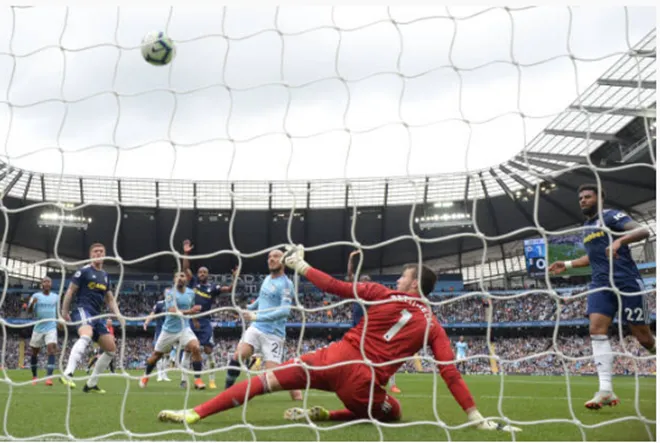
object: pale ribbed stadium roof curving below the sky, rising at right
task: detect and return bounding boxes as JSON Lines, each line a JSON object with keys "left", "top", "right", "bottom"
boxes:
{"left": 0, "top": 30, "right": 656, "bottom": 209}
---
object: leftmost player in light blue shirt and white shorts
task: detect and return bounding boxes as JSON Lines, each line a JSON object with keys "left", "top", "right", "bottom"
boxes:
{"left": 27, "top": 277, "right": 60, "bottom": 386}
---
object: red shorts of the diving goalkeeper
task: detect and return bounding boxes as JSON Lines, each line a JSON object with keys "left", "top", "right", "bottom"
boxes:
{"left": 274, "top": 340, "right": 401, "bottom": 421}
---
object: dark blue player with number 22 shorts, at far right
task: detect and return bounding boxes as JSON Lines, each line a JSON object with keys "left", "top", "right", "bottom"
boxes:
{"left": 548, "top": 184, "right": 655, "bottom": 409}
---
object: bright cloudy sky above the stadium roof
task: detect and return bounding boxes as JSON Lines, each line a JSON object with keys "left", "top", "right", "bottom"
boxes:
{"left": 0, "top": 7, "right": 655, "bottom": 180}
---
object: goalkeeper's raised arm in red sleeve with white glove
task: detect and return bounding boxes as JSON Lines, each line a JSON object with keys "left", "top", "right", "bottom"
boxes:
{"left": 282, "top": 245, "right": 388, "bottom": 300}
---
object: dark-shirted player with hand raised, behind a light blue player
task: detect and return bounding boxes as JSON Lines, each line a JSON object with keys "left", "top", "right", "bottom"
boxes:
{"left": 181, "top": 240, "right": 231, "bottom": 389}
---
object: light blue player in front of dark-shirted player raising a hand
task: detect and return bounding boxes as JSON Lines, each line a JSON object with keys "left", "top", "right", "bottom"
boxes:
{"left": 140, "top": 272, "right": 206, "bottom": 389}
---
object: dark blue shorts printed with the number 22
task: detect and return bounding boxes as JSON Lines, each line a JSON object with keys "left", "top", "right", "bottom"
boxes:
{"left": 587, "top": 280, "right": 651, "bottom": 325}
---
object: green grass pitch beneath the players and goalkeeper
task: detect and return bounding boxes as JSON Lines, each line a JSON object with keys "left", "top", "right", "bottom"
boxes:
{"left": 0, "top": 370, "right": 656, "bottom": 441}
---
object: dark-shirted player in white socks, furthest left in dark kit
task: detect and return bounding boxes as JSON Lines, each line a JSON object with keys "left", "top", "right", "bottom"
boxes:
{"left": 60, "top": 243, "right": 124, "bottom": 394}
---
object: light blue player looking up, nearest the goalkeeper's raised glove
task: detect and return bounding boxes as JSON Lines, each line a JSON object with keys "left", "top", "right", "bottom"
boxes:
{"left": 225, "top": 249, "right": 302, "bottom": 400}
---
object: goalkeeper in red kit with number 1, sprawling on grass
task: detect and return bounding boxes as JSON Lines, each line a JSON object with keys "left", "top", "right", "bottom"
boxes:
{"left": 158, "top": 246, "right": 520, "bottom": 432}
